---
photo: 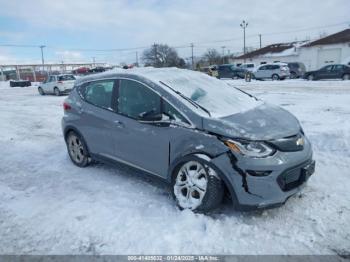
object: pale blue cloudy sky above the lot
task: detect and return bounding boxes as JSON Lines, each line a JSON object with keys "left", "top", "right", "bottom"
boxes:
{"left": 0, "top": 0, "right": 350, "bottom": 63}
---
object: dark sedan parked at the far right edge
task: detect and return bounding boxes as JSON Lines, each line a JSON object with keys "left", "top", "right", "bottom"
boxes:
{"left": 304, "top": 64, "right": 350, "bottom": 81}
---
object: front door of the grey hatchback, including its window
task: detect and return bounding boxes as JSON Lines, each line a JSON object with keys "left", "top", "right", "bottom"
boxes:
{"left": 110, "top": 79, "right": 172, "bottom": 178}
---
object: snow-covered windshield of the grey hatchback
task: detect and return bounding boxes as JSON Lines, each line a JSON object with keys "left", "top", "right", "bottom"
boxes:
{"left": 133, "top": 68, "right": 262, "bottom": 117}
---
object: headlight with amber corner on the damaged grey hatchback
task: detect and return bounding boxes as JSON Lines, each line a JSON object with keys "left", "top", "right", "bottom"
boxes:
{"left": 224, "top": 139, "right": 275, "bottom": 158}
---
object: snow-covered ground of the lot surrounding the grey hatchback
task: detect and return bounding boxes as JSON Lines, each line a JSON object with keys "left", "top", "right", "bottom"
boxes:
{"left": 0, "top": 80, "right": 350, "bottom": 254}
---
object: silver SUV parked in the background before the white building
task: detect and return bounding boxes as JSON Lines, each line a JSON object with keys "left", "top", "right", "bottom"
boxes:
{"left": 254, "top": 63, "right": 290, "bottom": 80}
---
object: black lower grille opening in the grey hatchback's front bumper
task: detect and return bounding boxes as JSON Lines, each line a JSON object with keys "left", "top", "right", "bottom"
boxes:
{"left": 277, "top": 160, "right": 315, "bottom": 192}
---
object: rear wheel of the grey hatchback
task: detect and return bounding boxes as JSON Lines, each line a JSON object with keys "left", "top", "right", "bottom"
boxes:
{"left": 66, "top": 131, "right": 90, "bottom": 167}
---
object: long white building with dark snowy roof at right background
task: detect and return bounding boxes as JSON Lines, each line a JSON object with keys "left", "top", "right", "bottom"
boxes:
{"left": 230, "top": 29, "right": 350, "bottom": 70}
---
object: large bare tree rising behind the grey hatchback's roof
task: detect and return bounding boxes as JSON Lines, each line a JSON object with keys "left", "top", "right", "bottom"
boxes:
{"left": 142, "top": 44, "right": 186, "bottom": 68}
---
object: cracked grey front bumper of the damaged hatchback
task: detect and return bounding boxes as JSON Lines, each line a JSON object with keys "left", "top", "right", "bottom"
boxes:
{"left": 212, "top": 137, "right": 315, "bottom": 210}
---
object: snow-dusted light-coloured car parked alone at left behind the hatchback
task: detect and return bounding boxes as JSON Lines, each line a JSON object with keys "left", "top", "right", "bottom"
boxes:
{"left": 38, "top": 74, "right": 76, "bottom": 96}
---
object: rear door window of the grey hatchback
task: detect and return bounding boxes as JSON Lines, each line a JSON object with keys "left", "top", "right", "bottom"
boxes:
{"left": 81, "top": 80, "right": 114, "bottom": 110}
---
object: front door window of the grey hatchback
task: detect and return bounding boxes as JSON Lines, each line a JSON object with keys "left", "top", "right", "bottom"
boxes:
{"left": 118, "top": 80, "right": 160, "bottom": 119}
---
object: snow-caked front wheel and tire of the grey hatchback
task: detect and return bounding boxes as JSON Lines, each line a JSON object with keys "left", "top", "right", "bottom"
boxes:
{"left": 172, "top": 156, "right": 224, "bottom": 213}
